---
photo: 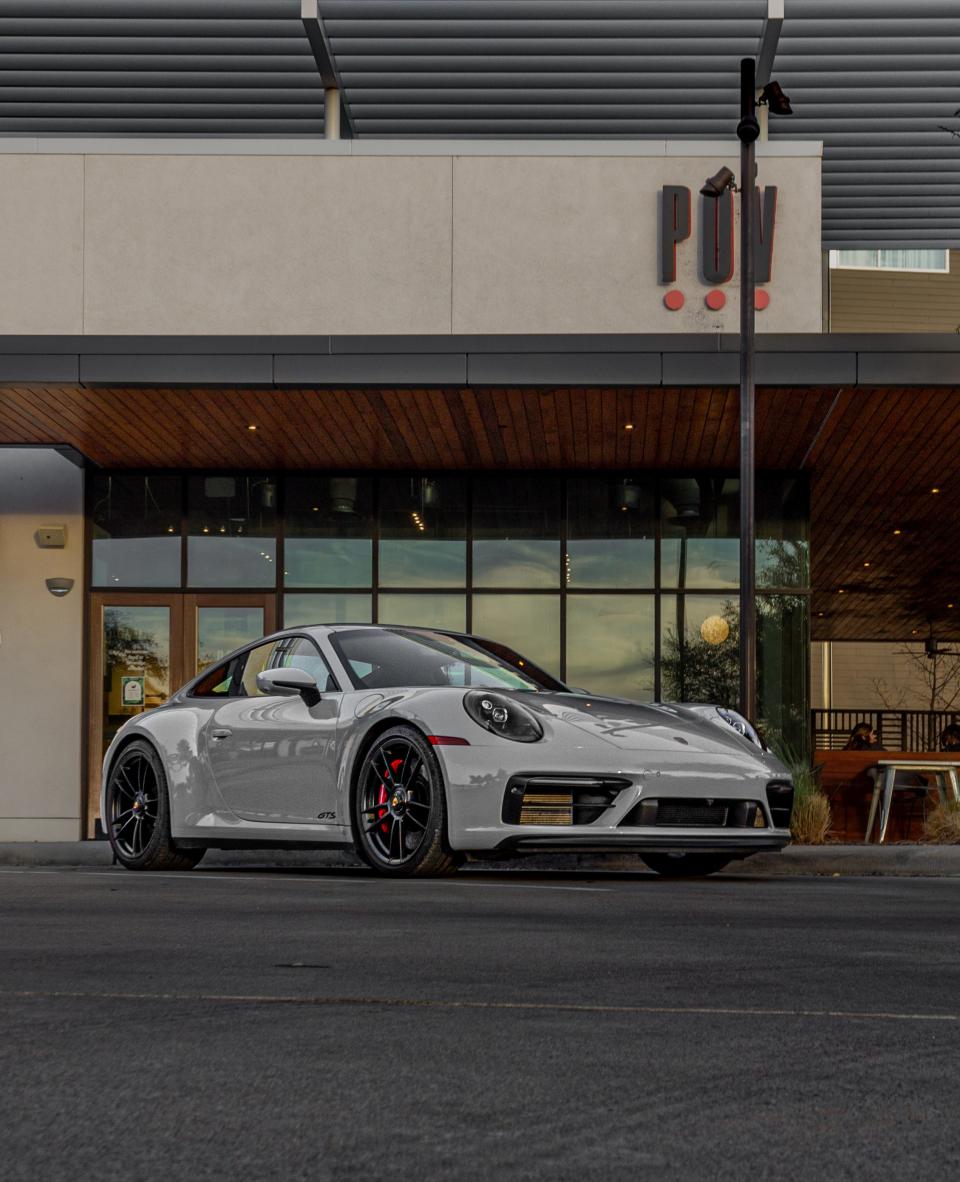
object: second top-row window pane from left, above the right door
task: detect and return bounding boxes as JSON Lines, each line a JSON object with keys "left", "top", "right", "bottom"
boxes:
{"left": 187, "top": 474, "right": 277, "bottom": 587}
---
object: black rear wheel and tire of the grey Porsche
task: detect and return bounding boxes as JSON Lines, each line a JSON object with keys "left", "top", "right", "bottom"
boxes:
{"left": 106, "top": 739, "right": 206, "bottom": 870}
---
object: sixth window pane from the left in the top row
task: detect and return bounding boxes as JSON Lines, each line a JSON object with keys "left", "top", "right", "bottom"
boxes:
{"left": 566, "top": 476, "right": 656, "bottom": 590}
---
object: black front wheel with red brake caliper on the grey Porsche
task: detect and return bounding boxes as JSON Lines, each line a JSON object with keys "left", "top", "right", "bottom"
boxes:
{"left": 351, "top": 726, "right": 462, "bottom": 878}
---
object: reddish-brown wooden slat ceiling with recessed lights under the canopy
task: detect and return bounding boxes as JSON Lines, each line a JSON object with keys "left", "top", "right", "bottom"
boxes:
{"left": 0, "top": 385, "right": 960, "bottom": 639}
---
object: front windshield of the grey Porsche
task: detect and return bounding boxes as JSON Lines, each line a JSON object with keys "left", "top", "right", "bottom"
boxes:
{"left": 330, "top": 628, "right": 564, "bottom": 693}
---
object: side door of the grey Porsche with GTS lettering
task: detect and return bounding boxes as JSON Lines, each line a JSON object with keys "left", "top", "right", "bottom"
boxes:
{"left": 203, "top": 636, "right": 346, "bottom": 825}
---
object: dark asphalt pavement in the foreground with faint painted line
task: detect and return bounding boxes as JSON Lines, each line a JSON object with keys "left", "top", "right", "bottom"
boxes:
{"left": 0, "top": 866, "right": 960, "bottom": 1182}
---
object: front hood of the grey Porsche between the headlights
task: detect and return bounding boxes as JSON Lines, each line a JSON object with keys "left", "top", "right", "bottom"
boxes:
{"left": 523, "top": 694, "right": 771, "bottom": 764}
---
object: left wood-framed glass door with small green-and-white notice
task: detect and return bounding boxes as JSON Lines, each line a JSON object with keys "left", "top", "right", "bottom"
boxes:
{"left": 86, "top": 592, "right": 184, "bottom": 837}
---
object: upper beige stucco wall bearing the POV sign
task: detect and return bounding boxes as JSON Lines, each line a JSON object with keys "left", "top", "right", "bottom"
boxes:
{"left": 0, "top": 139, "right": 822, "bottom": 335}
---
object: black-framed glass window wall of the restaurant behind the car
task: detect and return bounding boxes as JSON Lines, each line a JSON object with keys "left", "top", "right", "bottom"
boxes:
{"left": 87, "top": 472, "right": 810, "bottom": 748}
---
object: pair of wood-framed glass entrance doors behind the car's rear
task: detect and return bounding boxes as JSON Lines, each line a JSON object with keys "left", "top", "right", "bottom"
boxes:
{"left": 86, "top": 591, "right": 277, "bottom": 837}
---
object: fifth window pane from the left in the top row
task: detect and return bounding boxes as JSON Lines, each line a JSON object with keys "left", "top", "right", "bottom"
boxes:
{"left": 473, "top": 473, "right": 560, "bottom": 587}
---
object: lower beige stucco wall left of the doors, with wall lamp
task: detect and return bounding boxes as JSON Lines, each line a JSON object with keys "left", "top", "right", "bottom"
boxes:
{"left": 0, "top": 448, "right": 84, "bottom": 842}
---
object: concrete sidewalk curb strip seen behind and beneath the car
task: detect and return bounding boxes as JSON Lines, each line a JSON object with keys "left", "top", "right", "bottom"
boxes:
{"left": 0, "top": 842, "right": 960, "bottom": 878}
